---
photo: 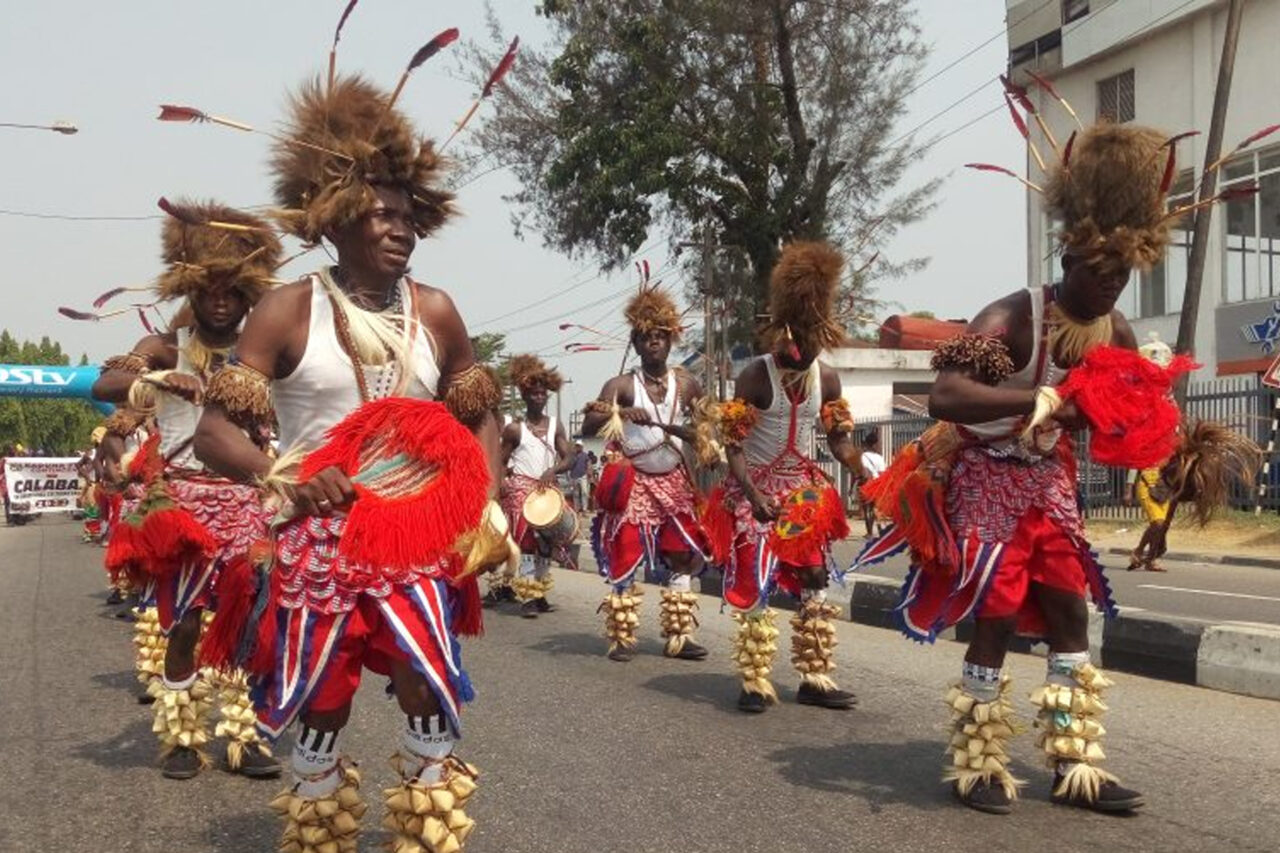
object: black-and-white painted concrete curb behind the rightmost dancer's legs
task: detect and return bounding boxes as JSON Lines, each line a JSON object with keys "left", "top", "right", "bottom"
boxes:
{"left": 849, "top": 576, "right": 1280, "bottom": 699}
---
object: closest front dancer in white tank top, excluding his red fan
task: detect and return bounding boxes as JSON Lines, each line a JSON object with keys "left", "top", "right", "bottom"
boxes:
{"left": 196, "top": 76, "right": 499, "bottom": 853}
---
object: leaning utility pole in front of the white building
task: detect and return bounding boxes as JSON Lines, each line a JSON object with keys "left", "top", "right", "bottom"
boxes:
{"left": 1174, "top": 0, "right": 1244, "bottom": 409}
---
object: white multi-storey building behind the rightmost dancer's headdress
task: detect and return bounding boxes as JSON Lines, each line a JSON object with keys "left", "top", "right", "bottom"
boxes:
{"left": 1006, "top": 0, "right": 1280, "bottom": 379}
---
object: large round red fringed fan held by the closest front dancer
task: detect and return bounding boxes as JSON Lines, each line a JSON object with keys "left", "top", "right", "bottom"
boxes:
{"left": 301, "top": 397, "right": 489, "bottom": 569}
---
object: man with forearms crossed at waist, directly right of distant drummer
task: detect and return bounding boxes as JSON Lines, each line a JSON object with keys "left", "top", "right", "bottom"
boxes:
{"left": 582, "top": 282, "right": 708, "bottom": 662}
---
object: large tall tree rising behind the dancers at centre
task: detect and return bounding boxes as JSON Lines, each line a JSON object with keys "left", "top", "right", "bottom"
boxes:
{"left": 466, "top": 0, "right": 936, "bottom": 350}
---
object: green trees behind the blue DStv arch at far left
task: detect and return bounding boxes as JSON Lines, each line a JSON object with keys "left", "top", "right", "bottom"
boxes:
{"left": 0, "top": 329, "right": 102, "bottom": 456}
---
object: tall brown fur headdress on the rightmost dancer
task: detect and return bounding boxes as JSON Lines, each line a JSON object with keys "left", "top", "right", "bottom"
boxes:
{"left": 1044, "top": 122, "right": 1174, "bottom": 270}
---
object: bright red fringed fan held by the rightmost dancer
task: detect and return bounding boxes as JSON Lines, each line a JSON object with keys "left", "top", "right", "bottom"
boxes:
{"left": 1057, "top": 346, "right": 1199, "bottom": 469}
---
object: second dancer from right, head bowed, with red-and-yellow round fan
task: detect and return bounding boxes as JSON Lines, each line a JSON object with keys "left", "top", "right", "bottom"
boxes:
{"left": 707, "top": 242, "right": 861, "bottom": 713}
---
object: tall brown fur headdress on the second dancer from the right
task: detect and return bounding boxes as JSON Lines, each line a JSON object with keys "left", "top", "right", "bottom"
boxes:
{"left": 762, "top": 241, "right": 845, "bottom": 355}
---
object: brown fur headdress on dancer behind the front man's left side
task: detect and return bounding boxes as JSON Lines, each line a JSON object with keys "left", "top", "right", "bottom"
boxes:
{"left": 155, "top": 201, "right": 283, "bottom": 302}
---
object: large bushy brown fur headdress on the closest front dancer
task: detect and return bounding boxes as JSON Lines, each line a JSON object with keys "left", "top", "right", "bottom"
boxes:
{"left": 271, "top": 74, "right": 453, "bottom": 245}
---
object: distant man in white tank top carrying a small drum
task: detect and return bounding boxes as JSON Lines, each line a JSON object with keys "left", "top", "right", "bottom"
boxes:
{"left": 502, "top": 355, "right": 573, "bottom": 619}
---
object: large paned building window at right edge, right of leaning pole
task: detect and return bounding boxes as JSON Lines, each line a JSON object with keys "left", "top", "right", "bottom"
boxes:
{"left": 1222, "top": 145, "right": 1280, "bottom": 302}
